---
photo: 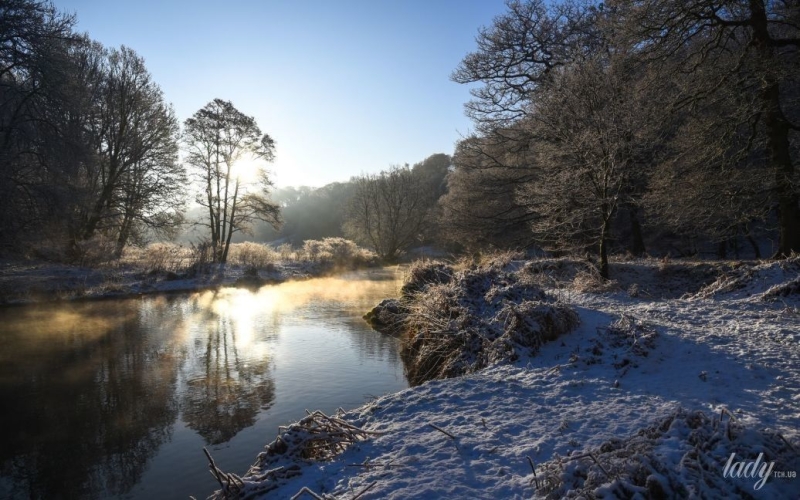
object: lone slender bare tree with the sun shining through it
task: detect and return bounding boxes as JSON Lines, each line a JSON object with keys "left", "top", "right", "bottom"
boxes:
{"left": 185, "top": 99, "right": 280, "bottom": 263}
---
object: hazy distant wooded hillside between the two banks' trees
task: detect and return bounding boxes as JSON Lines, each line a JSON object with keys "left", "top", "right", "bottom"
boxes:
{"left": 255, "top": 153, "right": 452, "bottom": 261}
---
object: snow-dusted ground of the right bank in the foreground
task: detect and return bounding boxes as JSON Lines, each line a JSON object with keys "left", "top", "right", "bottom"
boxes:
{"left": 216, "top": 259, "right": 800, "bottom": 499}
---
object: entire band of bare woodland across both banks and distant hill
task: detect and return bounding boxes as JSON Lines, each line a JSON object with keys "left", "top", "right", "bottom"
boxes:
{"left": 0, "top": 0, "right": 800, "bottom": 277}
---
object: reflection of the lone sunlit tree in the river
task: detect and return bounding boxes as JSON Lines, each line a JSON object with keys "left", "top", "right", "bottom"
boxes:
{"left": 182, "top": 315, "right": 275, "bottom": 444}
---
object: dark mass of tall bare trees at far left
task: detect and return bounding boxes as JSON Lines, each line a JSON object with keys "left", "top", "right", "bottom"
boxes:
{"left": 0, "top": 0, "right": 185, "bottom": 257}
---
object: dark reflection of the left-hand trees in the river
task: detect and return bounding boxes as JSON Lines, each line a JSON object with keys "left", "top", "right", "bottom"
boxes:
{"left": 0, "top": 301, "right": 177, "bottom": 498}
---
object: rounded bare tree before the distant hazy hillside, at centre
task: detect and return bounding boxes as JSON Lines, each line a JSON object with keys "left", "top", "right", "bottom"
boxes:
{"left": 344, "top": 166, "right": 435, "bottom": 260}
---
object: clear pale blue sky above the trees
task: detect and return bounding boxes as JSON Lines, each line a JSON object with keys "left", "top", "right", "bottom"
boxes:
{"left": 54, "top": 0, "right": 505, "bottom": 186}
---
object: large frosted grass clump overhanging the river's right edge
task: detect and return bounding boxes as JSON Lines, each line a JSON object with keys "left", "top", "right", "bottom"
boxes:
{"left": 392, "top": 263, "right": 578, "bottom": 385}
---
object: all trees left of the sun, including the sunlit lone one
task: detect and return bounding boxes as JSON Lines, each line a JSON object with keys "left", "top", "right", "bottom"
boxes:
{"left": 0, "top": 0, "right": 280, "bottom": 262}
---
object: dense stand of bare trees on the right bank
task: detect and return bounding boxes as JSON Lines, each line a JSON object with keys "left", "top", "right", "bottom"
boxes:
{"left": 441, "top": 0, "right": 800, "bottom": 277}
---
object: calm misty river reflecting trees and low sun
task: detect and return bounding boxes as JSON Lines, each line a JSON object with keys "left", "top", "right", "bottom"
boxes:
{"left": 0, "top": 268, "right": 408, "bottom": 500}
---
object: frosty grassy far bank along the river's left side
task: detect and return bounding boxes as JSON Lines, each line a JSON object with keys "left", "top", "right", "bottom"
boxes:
{"left": 0, "top": 238, "right": 376, "bottom": 303}
